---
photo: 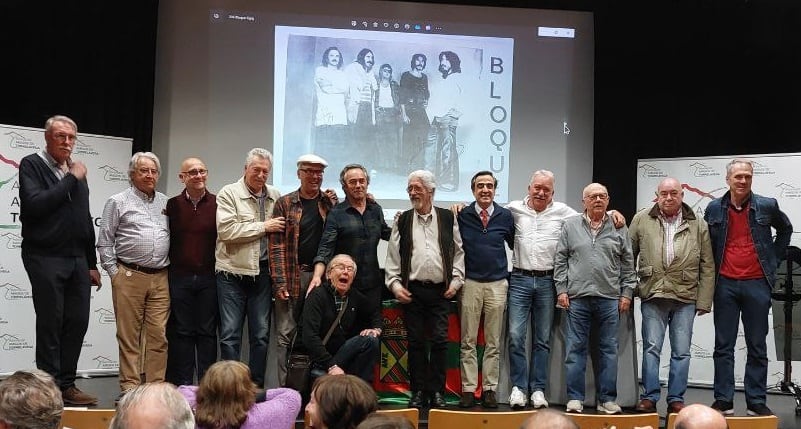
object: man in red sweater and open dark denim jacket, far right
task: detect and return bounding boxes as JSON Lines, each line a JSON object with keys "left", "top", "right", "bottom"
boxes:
{"left": 704, "top": 159, "right": 793, "bottom": 415}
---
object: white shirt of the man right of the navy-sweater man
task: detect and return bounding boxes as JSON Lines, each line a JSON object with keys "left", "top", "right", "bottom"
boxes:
{"left": 506, "top": 197, "right": 578, "bottom": 271}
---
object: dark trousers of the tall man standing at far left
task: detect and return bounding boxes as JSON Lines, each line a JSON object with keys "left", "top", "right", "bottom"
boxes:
{"left": 22, "top": 250, "right": 91, "bottom": 390}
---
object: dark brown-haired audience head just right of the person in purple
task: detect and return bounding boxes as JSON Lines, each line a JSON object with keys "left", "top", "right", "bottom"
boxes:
{"left": 306, "top": 375, "right": 378, "bottom": 429}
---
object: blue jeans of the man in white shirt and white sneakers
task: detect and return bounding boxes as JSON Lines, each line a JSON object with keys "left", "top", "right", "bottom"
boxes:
{"left": 508, "top": 273, "right": 556, "bottom": 392}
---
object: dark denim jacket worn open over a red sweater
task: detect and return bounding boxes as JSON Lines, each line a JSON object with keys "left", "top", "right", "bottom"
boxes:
{"left": 704, "top": 192, "right": 793, "bottom": 287}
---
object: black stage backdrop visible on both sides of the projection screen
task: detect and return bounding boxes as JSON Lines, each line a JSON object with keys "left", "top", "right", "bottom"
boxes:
{"left": 0, "top": 0, "right": 801, "bottom": 214}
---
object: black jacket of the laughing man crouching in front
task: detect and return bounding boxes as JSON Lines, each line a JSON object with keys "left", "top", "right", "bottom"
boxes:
{"left": 300, "top": 282, "right": 382, "bottom": 369}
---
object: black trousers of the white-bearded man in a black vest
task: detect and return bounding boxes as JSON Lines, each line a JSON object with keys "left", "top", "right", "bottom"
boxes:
{"left": 403, "top": 281, "right": 450, "bottom": 393}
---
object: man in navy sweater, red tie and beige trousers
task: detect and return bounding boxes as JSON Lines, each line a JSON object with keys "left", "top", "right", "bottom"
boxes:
{"left": 457, "top": 171, "right": 515, "bottom": 408}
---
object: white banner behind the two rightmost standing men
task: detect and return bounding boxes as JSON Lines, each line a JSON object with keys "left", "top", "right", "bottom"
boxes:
{"left": 636, "top": 153, "right": 801, "bottom": 387}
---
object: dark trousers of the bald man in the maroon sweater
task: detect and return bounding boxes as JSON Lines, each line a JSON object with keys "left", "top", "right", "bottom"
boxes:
{"left": 166, "top": 272, "right": 219, "bottom": 386}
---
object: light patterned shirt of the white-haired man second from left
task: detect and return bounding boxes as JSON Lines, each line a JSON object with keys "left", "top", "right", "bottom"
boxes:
{"left": 97, "top": 186, "right": 170, "bottom": 277}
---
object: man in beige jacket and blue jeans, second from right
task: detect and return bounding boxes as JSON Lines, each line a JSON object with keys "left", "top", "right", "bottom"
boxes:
{"left": 629, "top": 177, "right": 715, "bottom": 413}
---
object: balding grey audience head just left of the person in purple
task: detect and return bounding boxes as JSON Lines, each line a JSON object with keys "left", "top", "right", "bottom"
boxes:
{"left": 109, "top": 383, "right": 195, "bottom": 429}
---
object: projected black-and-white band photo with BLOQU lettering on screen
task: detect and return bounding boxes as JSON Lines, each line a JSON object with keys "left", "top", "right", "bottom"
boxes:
{"left": 273, "top": 26, "right": 514, "bottom": 201}
